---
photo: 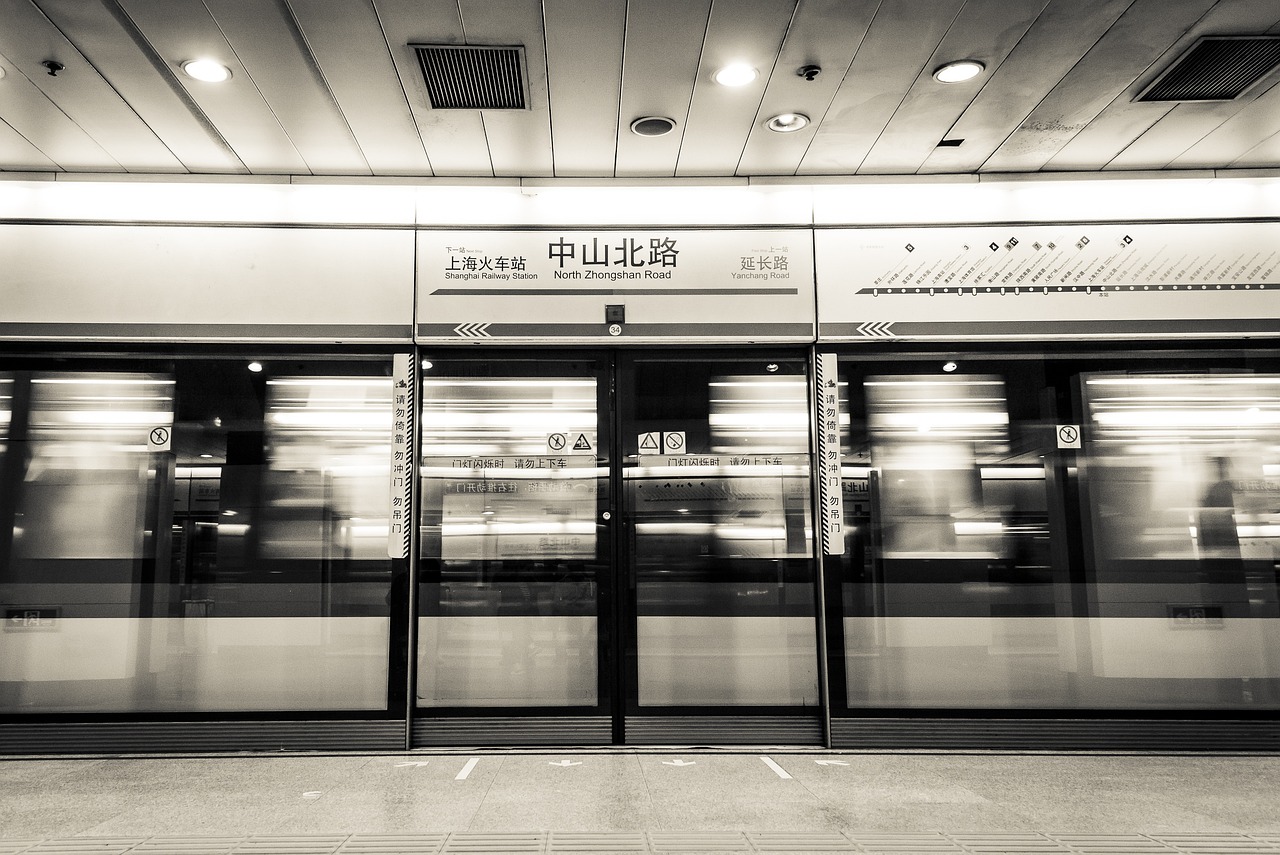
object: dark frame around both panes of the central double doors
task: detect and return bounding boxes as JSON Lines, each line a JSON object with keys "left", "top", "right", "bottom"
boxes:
{"left": 404, "top": 344, "right": 829, "bottom": 749}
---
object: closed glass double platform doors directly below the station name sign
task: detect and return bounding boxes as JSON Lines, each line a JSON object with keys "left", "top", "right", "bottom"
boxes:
{"left": 412, "top": 352, "right": 820, "bottom": 746}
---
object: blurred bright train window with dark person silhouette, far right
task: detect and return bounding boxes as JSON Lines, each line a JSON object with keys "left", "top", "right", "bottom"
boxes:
{"left": 1085, "top": 375, "right": 1280, "bottom": 564}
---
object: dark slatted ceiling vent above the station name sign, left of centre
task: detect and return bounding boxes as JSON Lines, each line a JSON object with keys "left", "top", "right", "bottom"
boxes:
{"left": 410, "top": 45, "right": 529, "bottom": 110}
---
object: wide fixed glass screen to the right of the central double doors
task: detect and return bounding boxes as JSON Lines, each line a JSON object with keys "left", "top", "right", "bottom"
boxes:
{"left": 828, "top": 355, "right": 1280, "bottom": 710}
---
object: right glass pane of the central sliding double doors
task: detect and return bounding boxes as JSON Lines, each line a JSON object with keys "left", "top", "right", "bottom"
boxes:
{"left": 623, "top": 360, "right": 818, "bottom": 708}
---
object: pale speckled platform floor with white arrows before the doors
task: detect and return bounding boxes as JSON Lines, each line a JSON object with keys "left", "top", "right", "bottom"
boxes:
{"left": 0, "top": 749, "right": 1280, "bottom": 855}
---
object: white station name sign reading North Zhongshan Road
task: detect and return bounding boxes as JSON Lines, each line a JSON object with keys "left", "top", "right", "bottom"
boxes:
{"left": 417, "top": 228, "right": 814, "bottom": 342}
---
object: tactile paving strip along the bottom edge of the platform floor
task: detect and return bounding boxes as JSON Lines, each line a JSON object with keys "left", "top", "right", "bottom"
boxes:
{"left": 0, "top": 831, "right": 1280, "bottom": 855}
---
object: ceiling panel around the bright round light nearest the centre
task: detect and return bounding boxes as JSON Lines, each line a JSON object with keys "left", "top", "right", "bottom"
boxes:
{"left": 676, "top": 0, "right": 795, "bottom": 177}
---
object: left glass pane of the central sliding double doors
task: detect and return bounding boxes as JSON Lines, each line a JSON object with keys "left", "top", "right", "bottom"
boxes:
{"left": 417, "top": 366, "right": 607, "bottom": 708}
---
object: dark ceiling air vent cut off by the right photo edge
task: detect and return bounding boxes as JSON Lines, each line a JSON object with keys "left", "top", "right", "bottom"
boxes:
{"left": 1135, "top": 36, "right": 1280, "bottom": 101}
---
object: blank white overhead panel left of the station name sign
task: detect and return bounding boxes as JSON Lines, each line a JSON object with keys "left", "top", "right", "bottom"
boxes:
{"left": 0, "top": 224, "right": 413, "bottom": 342}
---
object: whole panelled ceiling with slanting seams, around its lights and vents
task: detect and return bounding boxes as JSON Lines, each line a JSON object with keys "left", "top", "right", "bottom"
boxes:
{"left": 0, "top": 0, "right": 1280, "bottom": 179}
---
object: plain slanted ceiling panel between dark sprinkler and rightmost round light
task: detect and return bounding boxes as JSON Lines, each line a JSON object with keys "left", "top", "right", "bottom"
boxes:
{"left": 800, "top": 0, "right": 964, "bottom": 175}
